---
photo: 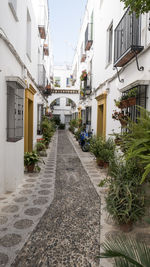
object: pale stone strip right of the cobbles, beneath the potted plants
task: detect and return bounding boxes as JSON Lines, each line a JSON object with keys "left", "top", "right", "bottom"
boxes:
{"left": 68, "top": 133, "right": 150, "bottom": 267}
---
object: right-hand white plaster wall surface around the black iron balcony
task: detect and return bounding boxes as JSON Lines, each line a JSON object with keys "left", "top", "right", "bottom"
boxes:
{"left": 72, "top": 0, "right": 150, "bottom": 136}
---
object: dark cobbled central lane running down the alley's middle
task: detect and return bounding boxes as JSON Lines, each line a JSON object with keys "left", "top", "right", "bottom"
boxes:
{"left": 12, "top": 131, "right": 100, "bottom": 267}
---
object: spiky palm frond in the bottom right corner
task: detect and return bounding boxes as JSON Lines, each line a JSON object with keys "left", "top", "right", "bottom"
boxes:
{"left": 99, "top": 235, "right": 150, "bottom": 267}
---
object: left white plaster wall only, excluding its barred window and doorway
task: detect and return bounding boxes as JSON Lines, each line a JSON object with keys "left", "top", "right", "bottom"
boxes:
{"left": 0, "top": 0, "right": 50, "bottom": 193}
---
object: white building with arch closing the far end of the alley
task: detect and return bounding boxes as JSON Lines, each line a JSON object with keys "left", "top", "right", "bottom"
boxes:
{"left": 48, "top": 66, "right": 79, "bottom": 128}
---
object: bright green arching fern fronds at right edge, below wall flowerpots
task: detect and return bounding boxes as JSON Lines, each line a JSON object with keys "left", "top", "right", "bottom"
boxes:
{"left": 122, "top": 107, "right": 150, "bottom": 183}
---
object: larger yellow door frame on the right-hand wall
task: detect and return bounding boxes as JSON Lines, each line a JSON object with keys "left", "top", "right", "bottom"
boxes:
{"left": 96, "top": 92, "right": 107, "bottom": 137}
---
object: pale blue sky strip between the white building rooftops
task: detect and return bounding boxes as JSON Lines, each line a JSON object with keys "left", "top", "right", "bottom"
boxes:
{"left": 49, "top": 0, "right": 87, "bottom": 65}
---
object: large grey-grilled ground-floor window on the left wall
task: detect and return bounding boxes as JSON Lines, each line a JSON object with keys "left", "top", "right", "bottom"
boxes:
{"left": 7, "top": 81, "right": 24, "bottom": 142}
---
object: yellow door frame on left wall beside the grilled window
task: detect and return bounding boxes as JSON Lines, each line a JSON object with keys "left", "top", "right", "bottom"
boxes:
{"left": 24, "top": 84, "right": 36, "bottom": 152}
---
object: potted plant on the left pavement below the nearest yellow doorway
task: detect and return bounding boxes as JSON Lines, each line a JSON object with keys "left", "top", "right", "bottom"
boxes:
{"left": 24, "top": 151, "right": 39, "bottom": 172}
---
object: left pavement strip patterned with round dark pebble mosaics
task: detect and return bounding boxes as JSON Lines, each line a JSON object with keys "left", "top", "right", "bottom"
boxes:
{"left": 0, "top": 133, "right": 57, "bottom": 267}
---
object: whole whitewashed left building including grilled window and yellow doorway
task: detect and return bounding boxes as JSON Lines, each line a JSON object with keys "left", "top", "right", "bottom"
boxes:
{"left": 0, "top": 0, "right": 50, "bottom": 193}
